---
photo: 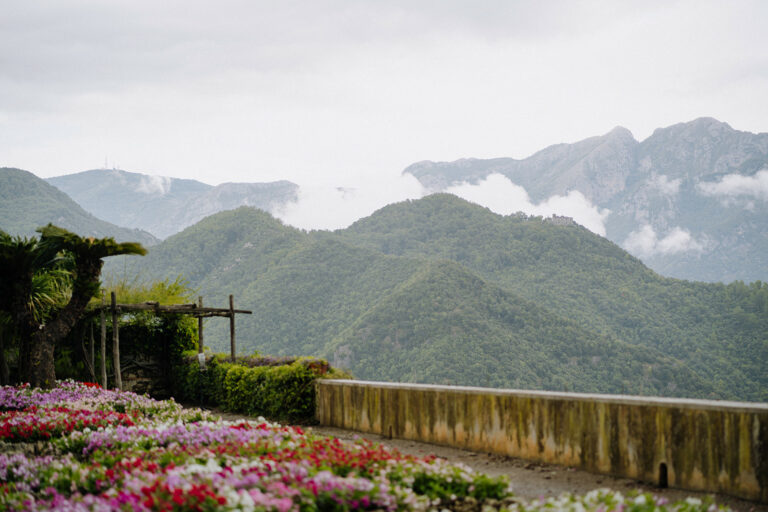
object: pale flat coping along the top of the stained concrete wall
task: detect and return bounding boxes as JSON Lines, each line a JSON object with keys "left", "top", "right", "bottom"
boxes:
{"left": 318, "top": 379, "right": 768, "bottom": 413}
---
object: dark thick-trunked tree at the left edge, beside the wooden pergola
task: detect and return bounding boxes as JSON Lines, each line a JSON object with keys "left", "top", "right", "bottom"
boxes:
{"left": 0, "top": 224, "right": 147, "bottom": 387}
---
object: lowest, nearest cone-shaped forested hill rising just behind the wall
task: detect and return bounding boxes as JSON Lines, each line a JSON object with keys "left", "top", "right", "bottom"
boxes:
{"left": 327, "top": 261, "right": 715, "bottom": 396}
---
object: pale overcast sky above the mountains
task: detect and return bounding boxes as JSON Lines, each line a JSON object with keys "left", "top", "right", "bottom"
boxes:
{"left": 0, "top": 0, "right": 768, "bottom": 232}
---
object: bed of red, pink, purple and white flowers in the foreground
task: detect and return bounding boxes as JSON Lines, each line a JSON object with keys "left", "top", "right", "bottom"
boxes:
{"left": 0, "top": 382, "right": 728, "bottom": 512}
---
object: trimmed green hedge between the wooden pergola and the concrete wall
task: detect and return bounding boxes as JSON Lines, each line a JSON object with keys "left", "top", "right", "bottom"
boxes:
{"left": 173, "top": 351, "right": 349, "bottom": 423}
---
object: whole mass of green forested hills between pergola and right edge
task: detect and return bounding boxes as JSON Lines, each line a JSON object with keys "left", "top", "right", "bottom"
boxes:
{"left": 109, "top": 198, "right": 768, "bottom": 400}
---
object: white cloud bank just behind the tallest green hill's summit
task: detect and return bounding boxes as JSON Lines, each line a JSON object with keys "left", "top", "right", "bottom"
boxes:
{"left": 446, "top": 174, "right": 611, "bottom": 236}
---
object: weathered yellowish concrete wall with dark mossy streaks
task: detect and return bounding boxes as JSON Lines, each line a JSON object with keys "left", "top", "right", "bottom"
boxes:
{"left": 317, "top": 380, "right": 768, "bottom": 502}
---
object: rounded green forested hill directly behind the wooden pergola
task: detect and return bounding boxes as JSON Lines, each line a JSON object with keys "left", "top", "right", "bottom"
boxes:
{"left": 109, "top": 207, "right": 426, "bottom": 355}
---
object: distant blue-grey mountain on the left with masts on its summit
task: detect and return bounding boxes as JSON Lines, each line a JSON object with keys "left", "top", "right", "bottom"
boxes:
{"left": 47, "top": 169, "right": 298, "bottom": 238}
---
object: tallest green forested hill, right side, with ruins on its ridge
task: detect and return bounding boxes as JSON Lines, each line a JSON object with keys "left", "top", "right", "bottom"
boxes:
{"left": 337, "top": 194, "right": 768, "bottom": 400}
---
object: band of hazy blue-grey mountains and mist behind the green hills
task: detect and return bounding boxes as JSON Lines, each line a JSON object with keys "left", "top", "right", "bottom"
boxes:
{"left": 33, "top": 118, "right": 768, "bottom": 282}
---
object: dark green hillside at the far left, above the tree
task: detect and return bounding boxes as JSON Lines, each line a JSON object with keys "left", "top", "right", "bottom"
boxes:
{"left": 0, "top": 167, "right": 158, "bottom": 246}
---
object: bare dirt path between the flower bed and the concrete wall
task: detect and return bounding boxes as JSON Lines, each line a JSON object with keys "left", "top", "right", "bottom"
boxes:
{"left": 210, "top": 411, "right": 768, "bottom": 512}
